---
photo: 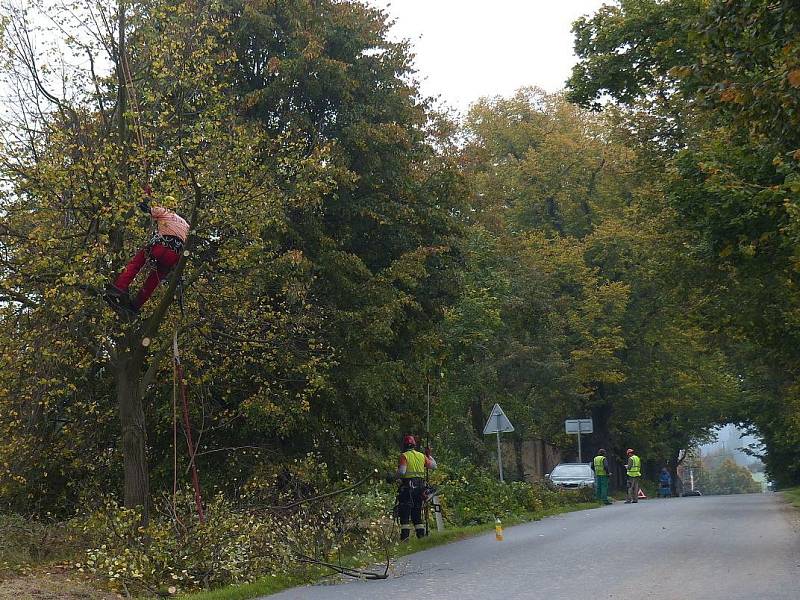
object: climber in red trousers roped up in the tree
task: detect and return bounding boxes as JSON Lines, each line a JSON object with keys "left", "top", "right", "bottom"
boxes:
{"left": 103, "top": 189, "right": 189, "bottom": 315}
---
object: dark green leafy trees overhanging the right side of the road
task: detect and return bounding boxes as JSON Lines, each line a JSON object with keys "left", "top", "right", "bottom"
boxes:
{"left": 568, "top": 0, "right": 800, "bottom": 484}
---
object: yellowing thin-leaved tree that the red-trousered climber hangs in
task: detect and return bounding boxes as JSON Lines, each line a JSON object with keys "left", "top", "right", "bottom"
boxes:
{"left": 0, "top": 3, "right": 335, "bottom": 509}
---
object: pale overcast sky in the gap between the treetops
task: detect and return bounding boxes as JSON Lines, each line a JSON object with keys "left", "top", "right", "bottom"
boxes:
{"left": 367, "top": 0, "right": 613, "bottom": 111}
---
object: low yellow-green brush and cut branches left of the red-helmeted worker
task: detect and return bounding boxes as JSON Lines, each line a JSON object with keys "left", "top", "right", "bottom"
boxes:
{"left": 77, "top": 478, "right": 394, "bottom": 594}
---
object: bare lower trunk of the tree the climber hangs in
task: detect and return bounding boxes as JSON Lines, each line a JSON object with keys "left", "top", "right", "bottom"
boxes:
{"left": 117, "top": 351, "right": 150, "bottom": 524}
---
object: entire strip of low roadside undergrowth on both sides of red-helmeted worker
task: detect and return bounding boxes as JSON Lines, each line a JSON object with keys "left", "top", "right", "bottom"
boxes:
{"left": 0, "top": 456, "right": 590, "bottom": 596}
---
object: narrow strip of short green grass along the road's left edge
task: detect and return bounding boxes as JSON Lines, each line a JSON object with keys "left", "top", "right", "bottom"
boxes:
{"left": 179, "top": 502, "right": 600, "bottom": 600}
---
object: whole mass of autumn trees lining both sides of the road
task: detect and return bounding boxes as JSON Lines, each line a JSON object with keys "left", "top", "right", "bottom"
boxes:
{"left": 0, "top": 0, "right": 800, "bottom": 576}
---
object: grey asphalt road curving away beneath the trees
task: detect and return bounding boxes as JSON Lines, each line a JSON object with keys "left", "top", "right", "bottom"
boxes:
{"left": 268, "top": 494, "right": 800, "bottom": 600}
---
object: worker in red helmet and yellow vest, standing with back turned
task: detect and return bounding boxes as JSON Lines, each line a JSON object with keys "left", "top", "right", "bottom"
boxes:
{"left": 397, "top": 435, "right": 436, "bottom": 541}
